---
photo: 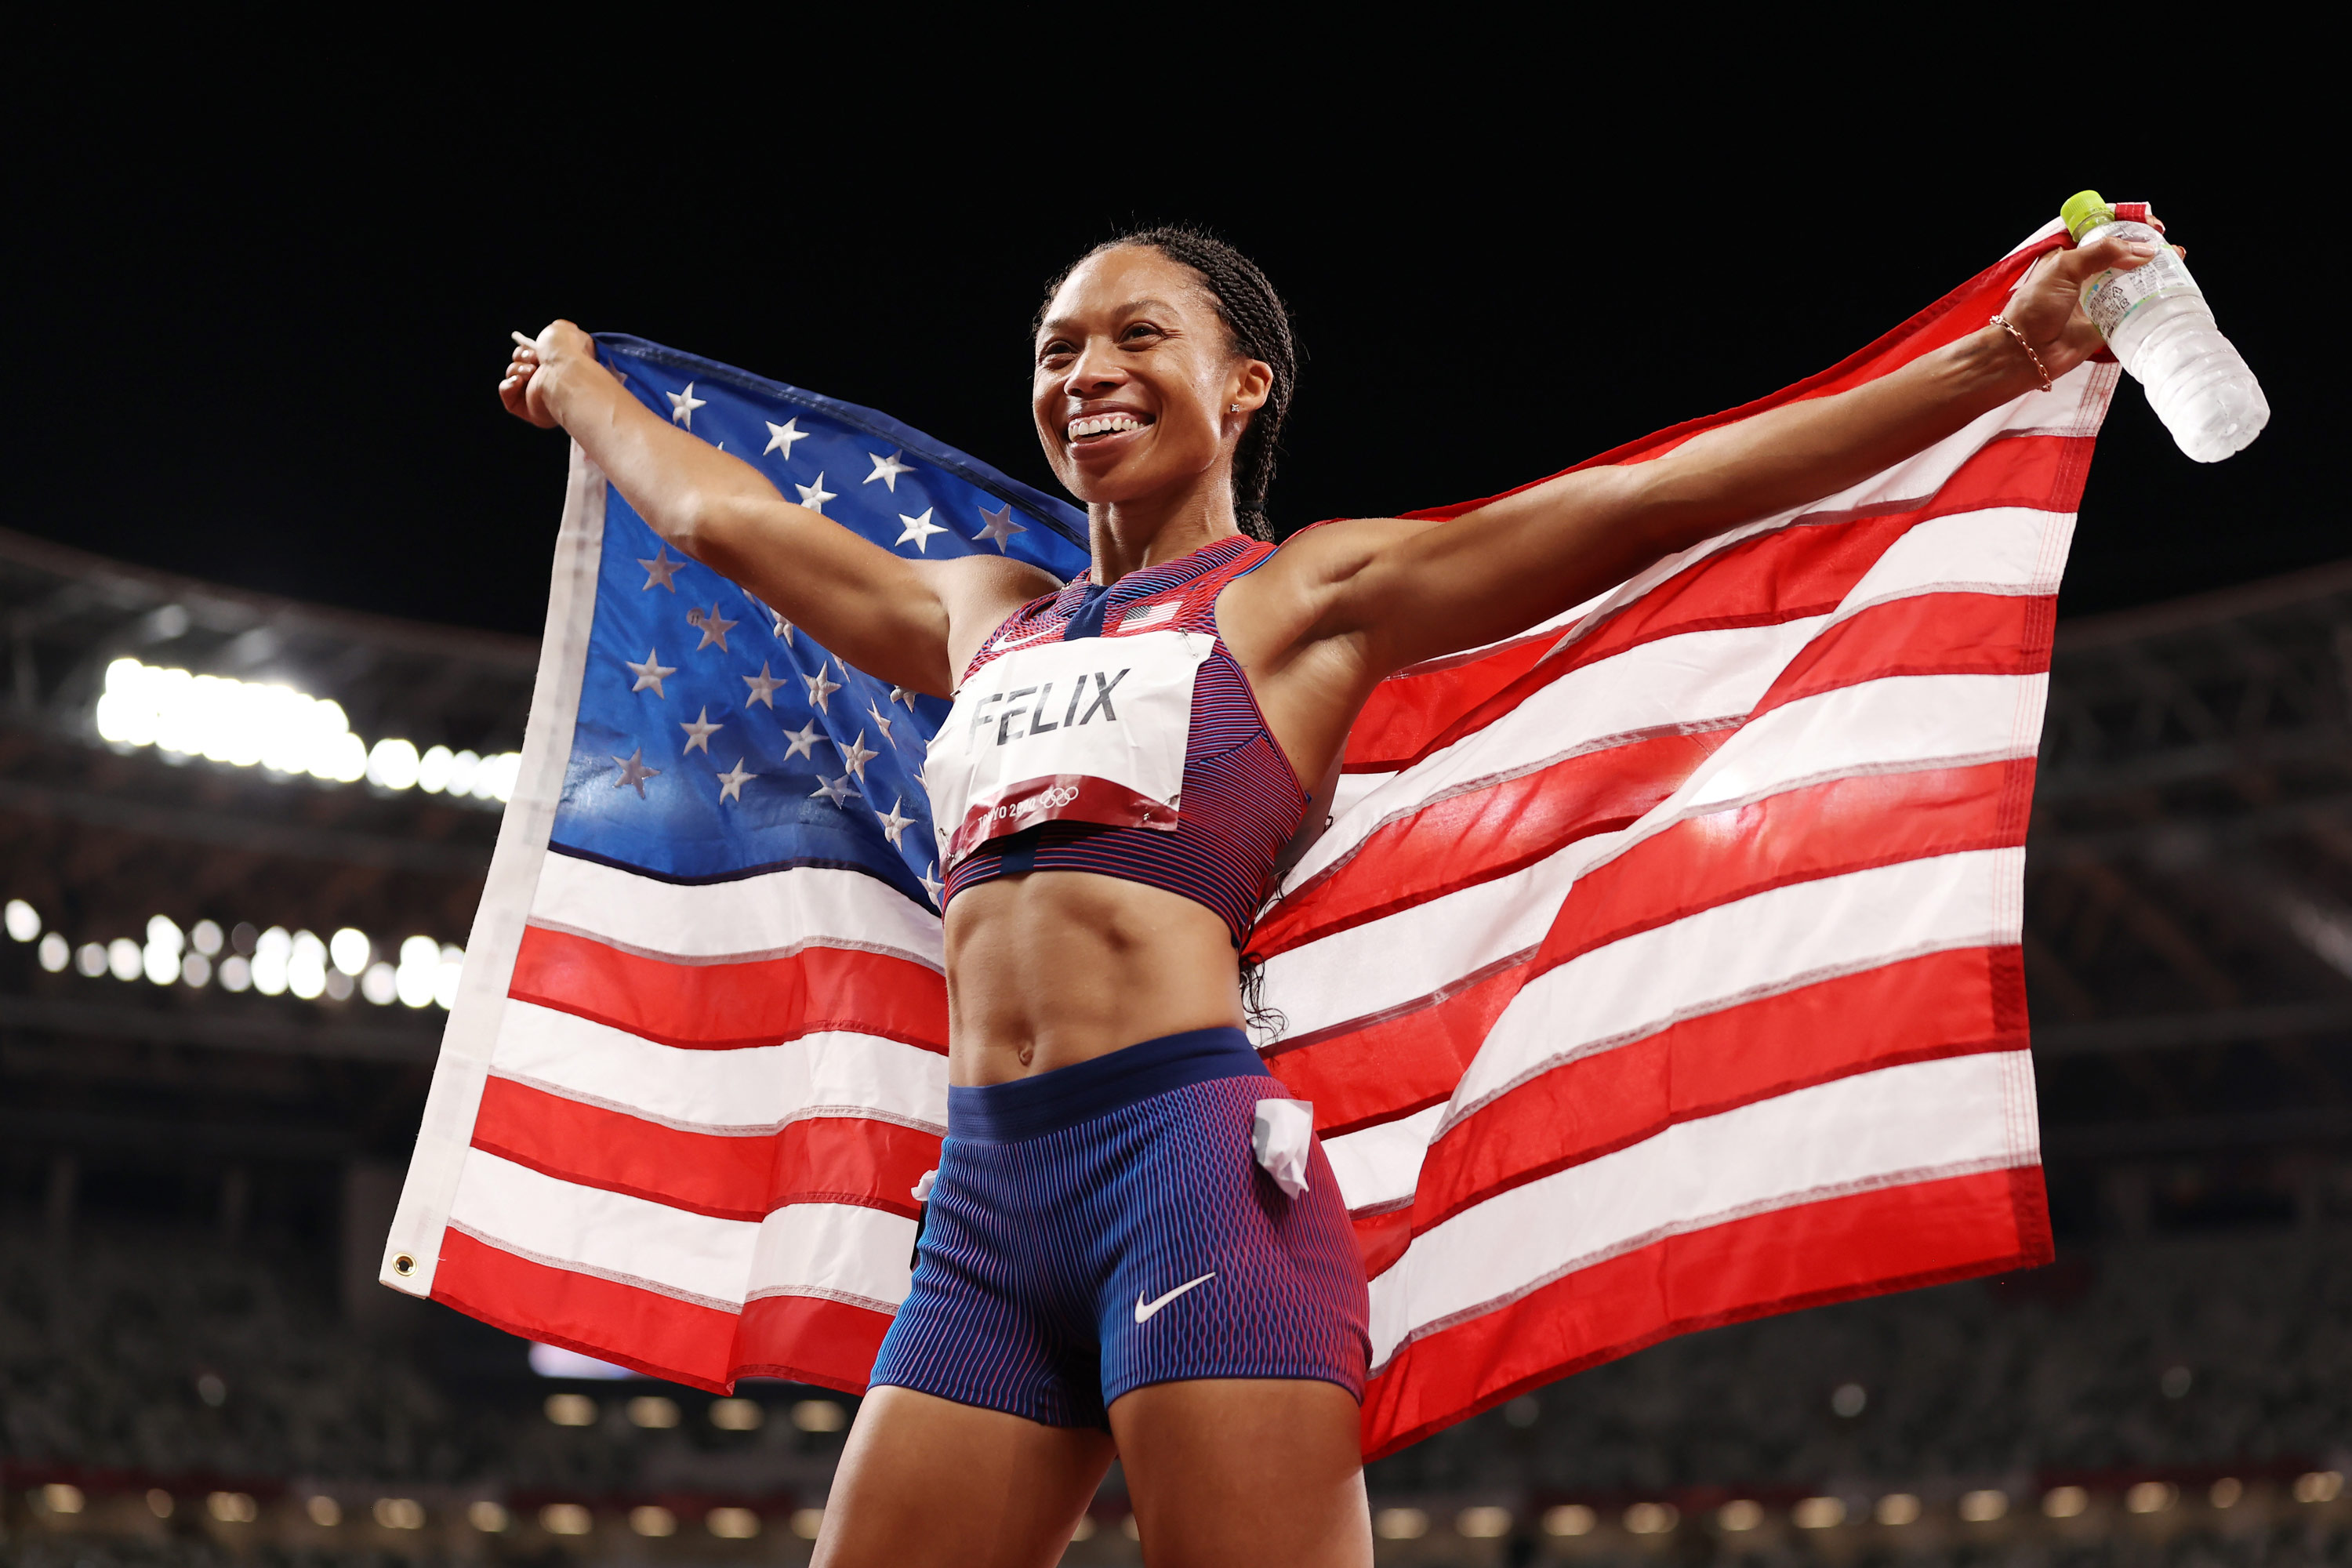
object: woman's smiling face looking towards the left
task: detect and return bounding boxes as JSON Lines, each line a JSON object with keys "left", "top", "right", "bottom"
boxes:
{"left": 1030, "top": 245, "right": 1272, "bottom": 510}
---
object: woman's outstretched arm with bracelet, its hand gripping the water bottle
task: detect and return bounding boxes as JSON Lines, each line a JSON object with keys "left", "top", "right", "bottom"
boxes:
{"left": 1296, "top": 240, "right": 2152, "bottom": 680}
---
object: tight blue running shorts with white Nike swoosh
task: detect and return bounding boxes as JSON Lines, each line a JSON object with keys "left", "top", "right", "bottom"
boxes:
{"left": 873, "top": 1029, "right": 1371, "bottom": 1427}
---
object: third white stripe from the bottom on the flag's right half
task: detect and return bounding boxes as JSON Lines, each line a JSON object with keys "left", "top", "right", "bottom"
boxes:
{"left": 1265, "top": 675, "right": 2049, "bottom": 1034}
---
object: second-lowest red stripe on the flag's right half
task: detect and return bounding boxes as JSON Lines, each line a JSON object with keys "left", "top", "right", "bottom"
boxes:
{"left": 1388, "top": 947, "right": 2027, "bottom": 1260}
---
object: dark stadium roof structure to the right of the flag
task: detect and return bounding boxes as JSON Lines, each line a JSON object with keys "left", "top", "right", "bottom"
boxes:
{"left": 2025, "top": 562, "right": 2352, "bottom": 1159}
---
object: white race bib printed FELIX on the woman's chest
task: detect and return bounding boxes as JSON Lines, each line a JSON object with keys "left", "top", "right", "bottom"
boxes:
{"left": 922, "top": 633, "right": 1216, "bottom": 869}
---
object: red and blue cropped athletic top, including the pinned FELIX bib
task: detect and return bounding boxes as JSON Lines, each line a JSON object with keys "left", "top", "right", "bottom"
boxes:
{"left": 924, "top": 539, "right": 1308, "bottom": 945}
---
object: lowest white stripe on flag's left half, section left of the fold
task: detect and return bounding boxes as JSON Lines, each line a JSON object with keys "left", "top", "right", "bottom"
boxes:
{"left": 449, "top": 1149, "right": 760, "bottom": 1312}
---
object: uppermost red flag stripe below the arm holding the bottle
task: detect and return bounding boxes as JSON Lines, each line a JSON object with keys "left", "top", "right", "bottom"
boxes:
{"left": 1348, "top": 435, "right": 2091, "bottom": 774}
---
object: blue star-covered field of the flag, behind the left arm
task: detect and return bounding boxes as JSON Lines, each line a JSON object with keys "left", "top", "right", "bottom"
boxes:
{"left": 550, "top": 334, "right": 1087, "bottom": 907}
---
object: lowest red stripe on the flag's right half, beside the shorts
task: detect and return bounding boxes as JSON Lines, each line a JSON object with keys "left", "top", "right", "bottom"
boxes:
{"left": 1364, "top": 1168, "right": 2053, "bottom": 1460}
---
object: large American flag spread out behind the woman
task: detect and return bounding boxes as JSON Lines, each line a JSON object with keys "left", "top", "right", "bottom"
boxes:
{"left": 383, "top": 209, "right": 2140, "bottom": 1455}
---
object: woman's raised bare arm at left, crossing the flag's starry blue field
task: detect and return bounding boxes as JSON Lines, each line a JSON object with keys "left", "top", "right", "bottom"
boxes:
{"left": 499, "top": 322, "right": 1056, "bottom": 696}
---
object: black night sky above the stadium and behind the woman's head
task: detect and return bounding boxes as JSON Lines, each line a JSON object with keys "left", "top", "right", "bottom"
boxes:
{"left": 0, "top": 50, "right": 2352, "bottom": 633}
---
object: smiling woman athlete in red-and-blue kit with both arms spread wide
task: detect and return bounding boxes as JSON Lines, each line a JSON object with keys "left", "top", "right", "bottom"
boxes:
{"left": 499, "top": 230, "right": 2147, "bottom": 1568}
